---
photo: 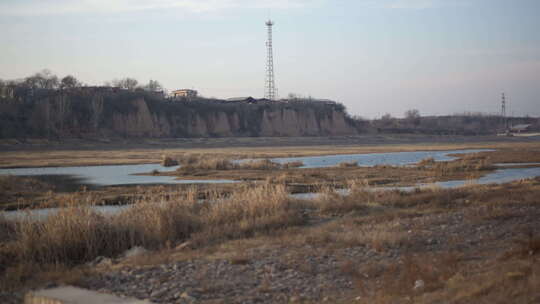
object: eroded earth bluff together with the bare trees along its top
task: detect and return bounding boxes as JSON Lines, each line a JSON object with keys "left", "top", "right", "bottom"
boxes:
{"left": 0, "top": 71, "right": 356, "bottom": 140}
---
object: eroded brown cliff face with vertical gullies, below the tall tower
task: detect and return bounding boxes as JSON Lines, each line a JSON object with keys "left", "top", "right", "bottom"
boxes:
{"left": 0, "top": 95, "right": 356, "bottom": 138}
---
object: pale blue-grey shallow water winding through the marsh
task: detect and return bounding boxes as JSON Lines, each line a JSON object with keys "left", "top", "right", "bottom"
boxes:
{"left": 0, "top": 149, "right": 540, "bottom": 218}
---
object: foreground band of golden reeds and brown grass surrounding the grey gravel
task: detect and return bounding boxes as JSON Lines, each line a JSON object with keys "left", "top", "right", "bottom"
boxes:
{"left": 0, "top": 179, "right": 540, "bottom": 303}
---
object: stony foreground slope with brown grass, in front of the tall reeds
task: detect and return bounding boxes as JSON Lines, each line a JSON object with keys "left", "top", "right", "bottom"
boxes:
{"left": 80, "top": 194, "right": 540, "bottom": 303}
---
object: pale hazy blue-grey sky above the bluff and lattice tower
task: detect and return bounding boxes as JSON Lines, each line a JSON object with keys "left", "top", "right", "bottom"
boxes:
{"left": 0, "top": 0, "right": 540, "bottom": 118}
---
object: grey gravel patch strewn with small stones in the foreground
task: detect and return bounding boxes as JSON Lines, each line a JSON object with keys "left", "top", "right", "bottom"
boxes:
{"left": 75, "top": 204, "right": 540, "bottom": 303}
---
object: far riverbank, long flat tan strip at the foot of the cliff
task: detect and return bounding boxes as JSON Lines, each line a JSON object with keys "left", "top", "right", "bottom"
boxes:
{"left": 0, "top": 135, "right": 540, "bottom": 168}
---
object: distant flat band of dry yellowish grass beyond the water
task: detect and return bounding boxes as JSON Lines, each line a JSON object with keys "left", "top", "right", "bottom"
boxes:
{"left": 0, "top": 138, "right": 540, "bottom": 167}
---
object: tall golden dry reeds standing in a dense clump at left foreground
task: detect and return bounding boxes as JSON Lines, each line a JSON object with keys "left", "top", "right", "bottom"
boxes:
{"left": 0, "top": 185, "right": 304, "bottom": 288}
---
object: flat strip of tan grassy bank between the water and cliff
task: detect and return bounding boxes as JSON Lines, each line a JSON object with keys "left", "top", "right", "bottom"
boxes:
{"left": 0, "top": 136, "right": 538, "bottom": 168}
